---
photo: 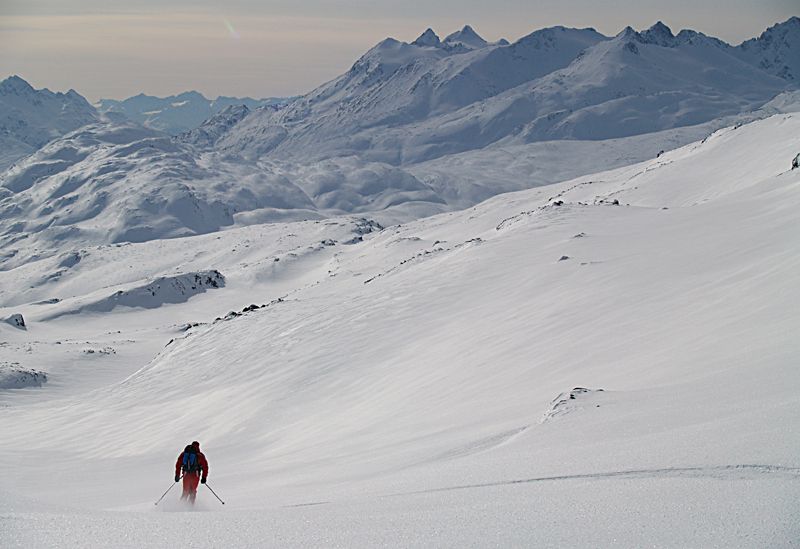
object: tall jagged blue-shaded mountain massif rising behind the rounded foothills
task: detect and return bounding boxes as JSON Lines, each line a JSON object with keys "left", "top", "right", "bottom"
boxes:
{"left": 217, "top": 19, "right": 800, "bottom": 164}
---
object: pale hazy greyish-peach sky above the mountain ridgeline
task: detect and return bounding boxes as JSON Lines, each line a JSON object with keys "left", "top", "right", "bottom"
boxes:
{"left": 0, "top": 0, "right": 800, "bottom": 101}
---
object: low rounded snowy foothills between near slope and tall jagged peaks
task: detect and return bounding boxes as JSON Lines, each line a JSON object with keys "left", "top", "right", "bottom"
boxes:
{"left": 7, "top": 107, "right": 768, "bottom": 268}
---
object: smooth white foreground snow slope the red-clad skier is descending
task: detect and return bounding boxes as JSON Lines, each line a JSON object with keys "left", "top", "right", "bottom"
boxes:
{"left": 0, "top": 114, "right": 800, "bottom": 547}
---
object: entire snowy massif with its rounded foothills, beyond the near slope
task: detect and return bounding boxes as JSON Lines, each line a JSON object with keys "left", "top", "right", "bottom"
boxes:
{"left": 0, "top": 19, "right": 796, "bottom": 268}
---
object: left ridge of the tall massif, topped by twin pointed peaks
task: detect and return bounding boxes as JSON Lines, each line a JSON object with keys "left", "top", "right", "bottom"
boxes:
{"left": 218, "top": 27, "right": 605, "bottom": 164}
